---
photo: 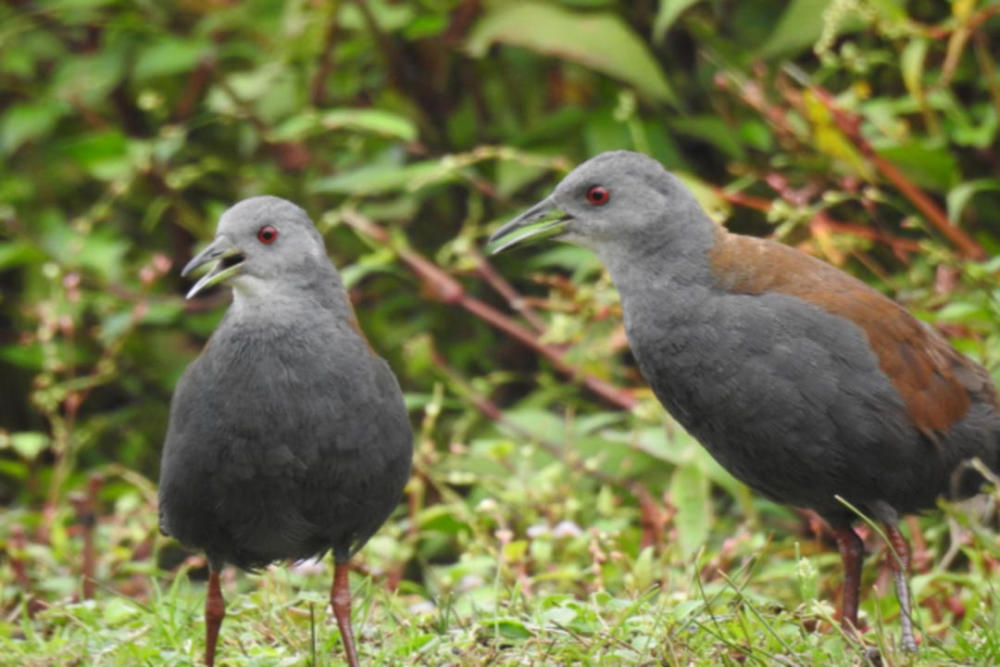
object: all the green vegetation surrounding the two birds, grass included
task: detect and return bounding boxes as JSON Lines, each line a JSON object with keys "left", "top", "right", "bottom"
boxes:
{"left": 0, "top": 0, "right": 1000, "bottom": 665}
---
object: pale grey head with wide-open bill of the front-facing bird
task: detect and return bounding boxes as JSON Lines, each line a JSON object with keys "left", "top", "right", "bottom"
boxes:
{"left": 181, "top": 196, "right": 329, "bottom": 299}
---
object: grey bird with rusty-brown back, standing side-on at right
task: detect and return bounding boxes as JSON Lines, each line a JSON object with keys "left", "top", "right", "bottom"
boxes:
{"left": 486, "top": 150, "right": 1000, "bottom": 651}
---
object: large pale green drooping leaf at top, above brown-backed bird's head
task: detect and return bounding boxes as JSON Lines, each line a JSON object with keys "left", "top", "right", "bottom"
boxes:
{"left": 466, "top": 2, "right": 677, "bottom": 104}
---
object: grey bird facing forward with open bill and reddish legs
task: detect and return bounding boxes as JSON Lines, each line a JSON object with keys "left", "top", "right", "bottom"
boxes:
{"left": 159, "top": 196, "right": 413, "bottom": 667}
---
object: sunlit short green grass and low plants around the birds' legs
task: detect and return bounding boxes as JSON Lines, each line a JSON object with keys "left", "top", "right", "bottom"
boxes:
{"left": 0, "top": 422, "right": 1000, "bottom": 666}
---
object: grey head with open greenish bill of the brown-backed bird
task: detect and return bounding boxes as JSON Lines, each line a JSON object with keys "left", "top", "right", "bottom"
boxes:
{"left": 487, "top": 151, "right": 700, "bottom": 254}
